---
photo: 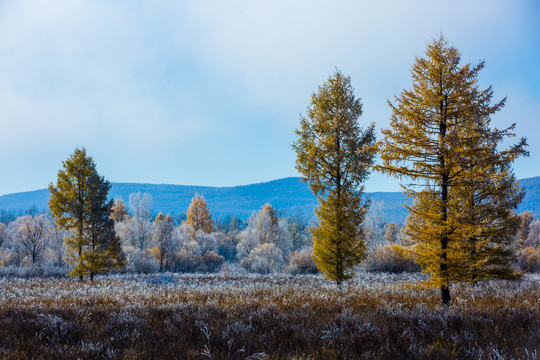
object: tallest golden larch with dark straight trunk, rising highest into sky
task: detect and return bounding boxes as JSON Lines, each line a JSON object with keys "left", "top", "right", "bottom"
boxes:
{"left": 376, "top": 36, "right": 526, "bottom": 305}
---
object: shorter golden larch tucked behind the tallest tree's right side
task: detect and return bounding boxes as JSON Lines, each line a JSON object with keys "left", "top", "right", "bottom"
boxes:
{"left": 450, "top": 134, "right": 525, "bottom": 283}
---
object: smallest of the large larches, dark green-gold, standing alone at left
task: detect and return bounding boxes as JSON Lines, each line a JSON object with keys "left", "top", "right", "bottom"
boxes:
{"left": 49, "top": 148, "right": 125, "bottom": 281}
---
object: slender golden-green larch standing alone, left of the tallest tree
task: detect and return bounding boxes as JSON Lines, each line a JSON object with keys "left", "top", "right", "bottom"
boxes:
{"left": 292, "top": 70, "right": 375, "bottom": 286}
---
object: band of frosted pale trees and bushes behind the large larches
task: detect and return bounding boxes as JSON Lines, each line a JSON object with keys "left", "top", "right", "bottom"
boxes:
{"left": 0, "top": 198, "right": 540, "bottom": 276}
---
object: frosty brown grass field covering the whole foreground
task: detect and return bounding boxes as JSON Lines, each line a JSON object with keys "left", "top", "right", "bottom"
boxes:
{"left": 0, "top": 273, "right": 540, "bottom": 360}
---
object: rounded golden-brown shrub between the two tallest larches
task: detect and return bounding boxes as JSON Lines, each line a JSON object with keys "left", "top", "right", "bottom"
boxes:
{"left": 365, "top": 244, "right": 420, "bottom": 273}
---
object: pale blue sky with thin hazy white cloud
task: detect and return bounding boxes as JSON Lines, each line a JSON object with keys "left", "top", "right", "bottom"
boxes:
{"left": 0, "top": 0, "right": 540, "bottom": 194}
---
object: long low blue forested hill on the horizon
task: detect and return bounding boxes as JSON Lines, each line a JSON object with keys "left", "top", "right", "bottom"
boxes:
{"left": 0, "top": 177, "right": 540, "bottom": 224}
